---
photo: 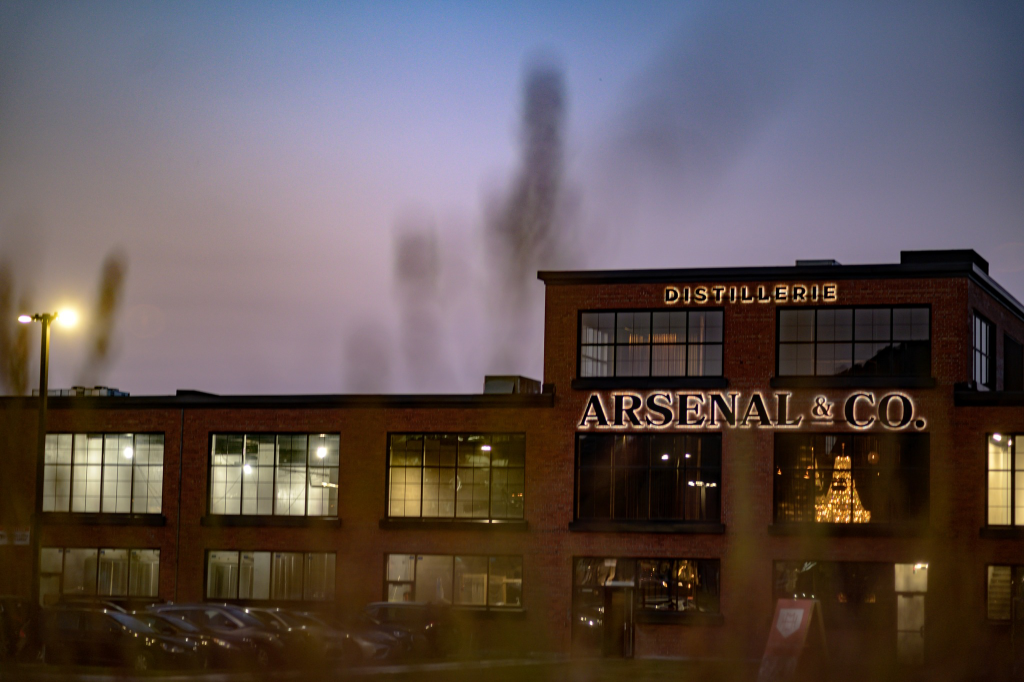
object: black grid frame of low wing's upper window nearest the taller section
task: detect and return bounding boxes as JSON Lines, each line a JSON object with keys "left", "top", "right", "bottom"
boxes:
{"left": 384, "top": 431, "right": 526, "bottom": 523}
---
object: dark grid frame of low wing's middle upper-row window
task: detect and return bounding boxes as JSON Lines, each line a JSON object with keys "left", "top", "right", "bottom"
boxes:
{"left": 206, "top": 431, "right": 341, "bottom": 524}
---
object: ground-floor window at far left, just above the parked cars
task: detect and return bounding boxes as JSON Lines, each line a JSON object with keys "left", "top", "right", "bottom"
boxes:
{"left": 39, "top": 547, "right": 160, "bottom": 604}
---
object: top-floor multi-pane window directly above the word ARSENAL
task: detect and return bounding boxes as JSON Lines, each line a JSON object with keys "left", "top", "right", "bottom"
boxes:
{"left": 579, "top": 310, "right": 723, "bottom": 377}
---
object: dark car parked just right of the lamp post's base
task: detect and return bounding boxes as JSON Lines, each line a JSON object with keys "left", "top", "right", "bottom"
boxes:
{"left": 29, "top": 608, "right": 202, "bottom": 671}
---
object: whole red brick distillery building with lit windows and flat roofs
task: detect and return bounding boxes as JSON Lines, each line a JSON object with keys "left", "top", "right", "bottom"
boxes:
{"left": 0, "top": 251, "right": 1024, "bottom": 676}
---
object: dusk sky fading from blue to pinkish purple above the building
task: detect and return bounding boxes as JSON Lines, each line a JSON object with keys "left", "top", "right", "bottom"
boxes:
{"left": 0, "top": 0, "right": 1024, "bottom": 395}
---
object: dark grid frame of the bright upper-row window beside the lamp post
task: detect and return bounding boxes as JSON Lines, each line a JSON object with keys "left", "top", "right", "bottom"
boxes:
{"left": 36, "top": 431, "right": 167, "bottom": 517}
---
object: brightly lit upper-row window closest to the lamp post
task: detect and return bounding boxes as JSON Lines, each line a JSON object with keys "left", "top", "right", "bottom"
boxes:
{"left": 42, "top": 433, "right": 164, "bottom": 514}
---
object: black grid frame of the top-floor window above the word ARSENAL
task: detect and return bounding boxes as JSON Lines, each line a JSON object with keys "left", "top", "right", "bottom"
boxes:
{"left": 575, "top": 307, "right": 726, "bottom": 382}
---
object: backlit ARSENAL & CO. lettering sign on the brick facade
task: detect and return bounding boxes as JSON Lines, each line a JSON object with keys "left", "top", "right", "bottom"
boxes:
{"left": 580, "top": 391, "right": 925, "bottom": 430}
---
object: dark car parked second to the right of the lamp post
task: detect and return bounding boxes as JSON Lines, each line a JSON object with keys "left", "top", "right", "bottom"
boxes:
{"left": 145, "top": 604, "right": 288, "bottom": 669}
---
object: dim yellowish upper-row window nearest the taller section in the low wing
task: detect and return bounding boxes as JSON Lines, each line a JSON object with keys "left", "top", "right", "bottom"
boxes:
{"left": 388, "top": 433, "right": 526, "bottom": 519}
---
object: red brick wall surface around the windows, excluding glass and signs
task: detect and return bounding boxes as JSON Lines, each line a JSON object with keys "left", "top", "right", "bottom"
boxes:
{"left": 0, "top": 270, "right": 1024, "bottom": 667}
